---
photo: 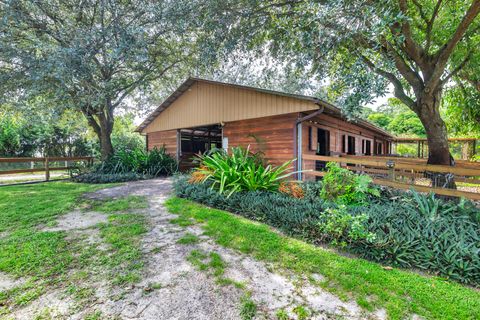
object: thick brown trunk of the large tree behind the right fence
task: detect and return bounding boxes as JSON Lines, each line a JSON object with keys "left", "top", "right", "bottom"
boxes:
{"left": 417, "top": 91, "right": 456, "bottom": 188}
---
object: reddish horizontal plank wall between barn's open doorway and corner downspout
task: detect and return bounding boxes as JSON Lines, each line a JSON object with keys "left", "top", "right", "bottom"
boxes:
{"left": 223, "top": 113, "right": 298, "bottom": 165}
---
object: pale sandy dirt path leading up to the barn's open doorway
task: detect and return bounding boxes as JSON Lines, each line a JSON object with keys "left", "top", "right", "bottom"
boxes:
{"left": 86, "top": 180, "right": 382, "bottom": 319}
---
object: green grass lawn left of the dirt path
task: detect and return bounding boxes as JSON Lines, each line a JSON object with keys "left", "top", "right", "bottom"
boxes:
{"left": 0, "top": 182, "right": 146, "bottom": 317}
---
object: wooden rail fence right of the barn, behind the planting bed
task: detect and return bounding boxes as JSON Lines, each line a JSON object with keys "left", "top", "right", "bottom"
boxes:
{"left": 302, "top": 155, "right": 480, "bottom": 200}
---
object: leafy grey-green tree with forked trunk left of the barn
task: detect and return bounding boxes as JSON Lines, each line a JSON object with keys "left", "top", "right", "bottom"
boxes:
{"left": 0, "top": 0, "right": 202, "bottom": 159}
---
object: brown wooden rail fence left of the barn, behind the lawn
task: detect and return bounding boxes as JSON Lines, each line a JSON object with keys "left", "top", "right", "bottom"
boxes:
{"left": 0, "top": 157, "right": 93, "bottom": 181}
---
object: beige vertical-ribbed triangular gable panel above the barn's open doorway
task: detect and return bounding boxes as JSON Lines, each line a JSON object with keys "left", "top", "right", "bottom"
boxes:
{"left": 142, "top": 81, "right": 319, "bottom": 133}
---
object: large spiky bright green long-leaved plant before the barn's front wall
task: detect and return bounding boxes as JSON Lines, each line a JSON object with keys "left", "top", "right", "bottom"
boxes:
{"left": 192, "top": 147, "right": 292, "bottom": 196}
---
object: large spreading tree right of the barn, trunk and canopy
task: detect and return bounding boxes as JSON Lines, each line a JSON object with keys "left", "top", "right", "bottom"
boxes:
{"left": 209, "top": 0, "right": 480, "bottom": 172}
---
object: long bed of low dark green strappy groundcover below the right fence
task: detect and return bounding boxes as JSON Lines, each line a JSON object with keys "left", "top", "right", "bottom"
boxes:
{"left": 174, "top": 177, "right": 480, "bottom": 286}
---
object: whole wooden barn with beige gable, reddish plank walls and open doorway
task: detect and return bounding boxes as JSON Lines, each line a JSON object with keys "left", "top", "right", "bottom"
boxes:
{"left": 136, "top": 78, "right": 394, "bottom": 175}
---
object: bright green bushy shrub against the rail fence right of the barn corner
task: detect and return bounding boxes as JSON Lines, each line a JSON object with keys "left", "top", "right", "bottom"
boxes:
{"left": 321, "top": 162, "right": 380, "bottom": 205}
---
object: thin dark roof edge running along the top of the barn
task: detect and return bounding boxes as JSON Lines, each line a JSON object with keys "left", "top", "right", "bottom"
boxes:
{"left": 135, "top": 77, "right": 393, "bottom": 138}
